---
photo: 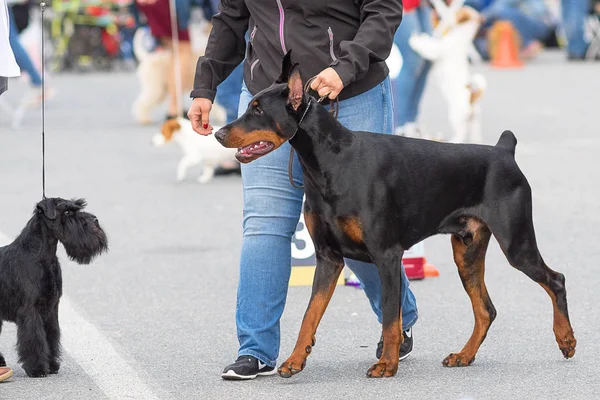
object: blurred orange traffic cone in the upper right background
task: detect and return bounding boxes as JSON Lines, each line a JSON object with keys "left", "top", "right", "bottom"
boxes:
{"left": 488, "top": 21, "right": 523, "bottom": 68}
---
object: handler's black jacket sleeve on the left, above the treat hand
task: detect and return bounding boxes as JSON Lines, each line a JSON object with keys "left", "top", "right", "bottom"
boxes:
{"left": 190, "top": 0, "right": 250, "bottom": 101}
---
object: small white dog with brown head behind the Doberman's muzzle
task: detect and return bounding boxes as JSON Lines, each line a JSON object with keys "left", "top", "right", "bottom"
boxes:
{"left": 152, "top": 118, "right": 238, "bottom": 183}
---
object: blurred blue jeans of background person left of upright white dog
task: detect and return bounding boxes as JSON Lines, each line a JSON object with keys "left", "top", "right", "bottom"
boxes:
{"left": 393, "top": 4, "right": 432, "bottom": 127}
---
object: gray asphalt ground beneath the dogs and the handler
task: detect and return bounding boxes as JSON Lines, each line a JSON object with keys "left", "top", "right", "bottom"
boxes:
{"left": 0, "top": 53, "right": 600, "bottom": 400}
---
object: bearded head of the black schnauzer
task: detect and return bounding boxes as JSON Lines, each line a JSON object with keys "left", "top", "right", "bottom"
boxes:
{"left": 35, "top": 197, "right": 108, "bottom": 264}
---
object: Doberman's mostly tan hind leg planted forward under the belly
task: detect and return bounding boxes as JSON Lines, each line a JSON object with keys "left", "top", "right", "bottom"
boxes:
{"left": 442, "top": 218, "right": 496, "bottom": 367}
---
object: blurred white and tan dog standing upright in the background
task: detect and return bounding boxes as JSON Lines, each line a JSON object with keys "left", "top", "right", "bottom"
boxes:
{"left": 408, "top": 2, "right": 487, "bottom": 143}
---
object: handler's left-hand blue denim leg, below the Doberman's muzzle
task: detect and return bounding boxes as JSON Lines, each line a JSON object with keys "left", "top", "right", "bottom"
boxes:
{"left": 236, "top": 86, "right": 303, "bottom": 367}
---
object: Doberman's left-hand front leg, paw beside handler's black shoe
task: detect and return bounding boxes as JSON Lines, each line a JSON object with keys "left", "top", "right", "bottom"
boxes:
{"left": 277, "top": 251, "right": 344, "bottom": 378}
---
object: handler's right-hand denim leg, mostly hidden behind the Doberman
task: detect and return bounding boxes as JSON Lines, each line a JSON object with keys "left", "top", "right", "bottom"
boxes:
{"left": 338, "top": 79, "right": 418, "bottom": 330}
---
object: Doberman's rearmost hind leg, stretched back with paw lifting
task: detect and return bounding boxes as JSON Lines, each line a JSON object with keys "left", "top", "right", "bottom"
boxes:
{"left": 489, "top": 183, "right": 577, "bottom": 358}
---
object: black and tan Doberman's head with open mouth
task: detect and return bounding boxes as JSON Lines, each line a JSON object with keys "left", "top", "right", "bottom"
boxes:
{"left": 215, "top": 51, "right": 306, "bottom": 163}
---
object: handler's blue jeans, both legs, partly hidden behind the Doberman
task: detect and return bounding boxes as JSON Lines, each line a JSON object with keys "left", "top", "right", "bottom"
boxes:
{"left": 236, "top": 79, "right": 418, "bottom": 366}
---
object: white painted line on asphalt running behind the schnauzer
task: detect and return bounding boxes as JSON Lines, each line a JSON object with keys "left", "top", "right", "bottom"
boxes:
{"left": 0, "top": 231, "right": 158, "bottom": 400}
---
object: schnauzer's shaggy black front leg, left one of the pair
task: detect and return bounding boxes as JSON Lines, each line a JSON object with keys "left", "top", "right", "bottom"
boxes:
{"left": 17, "top": 310, "right": 50, "bottom": 378}
